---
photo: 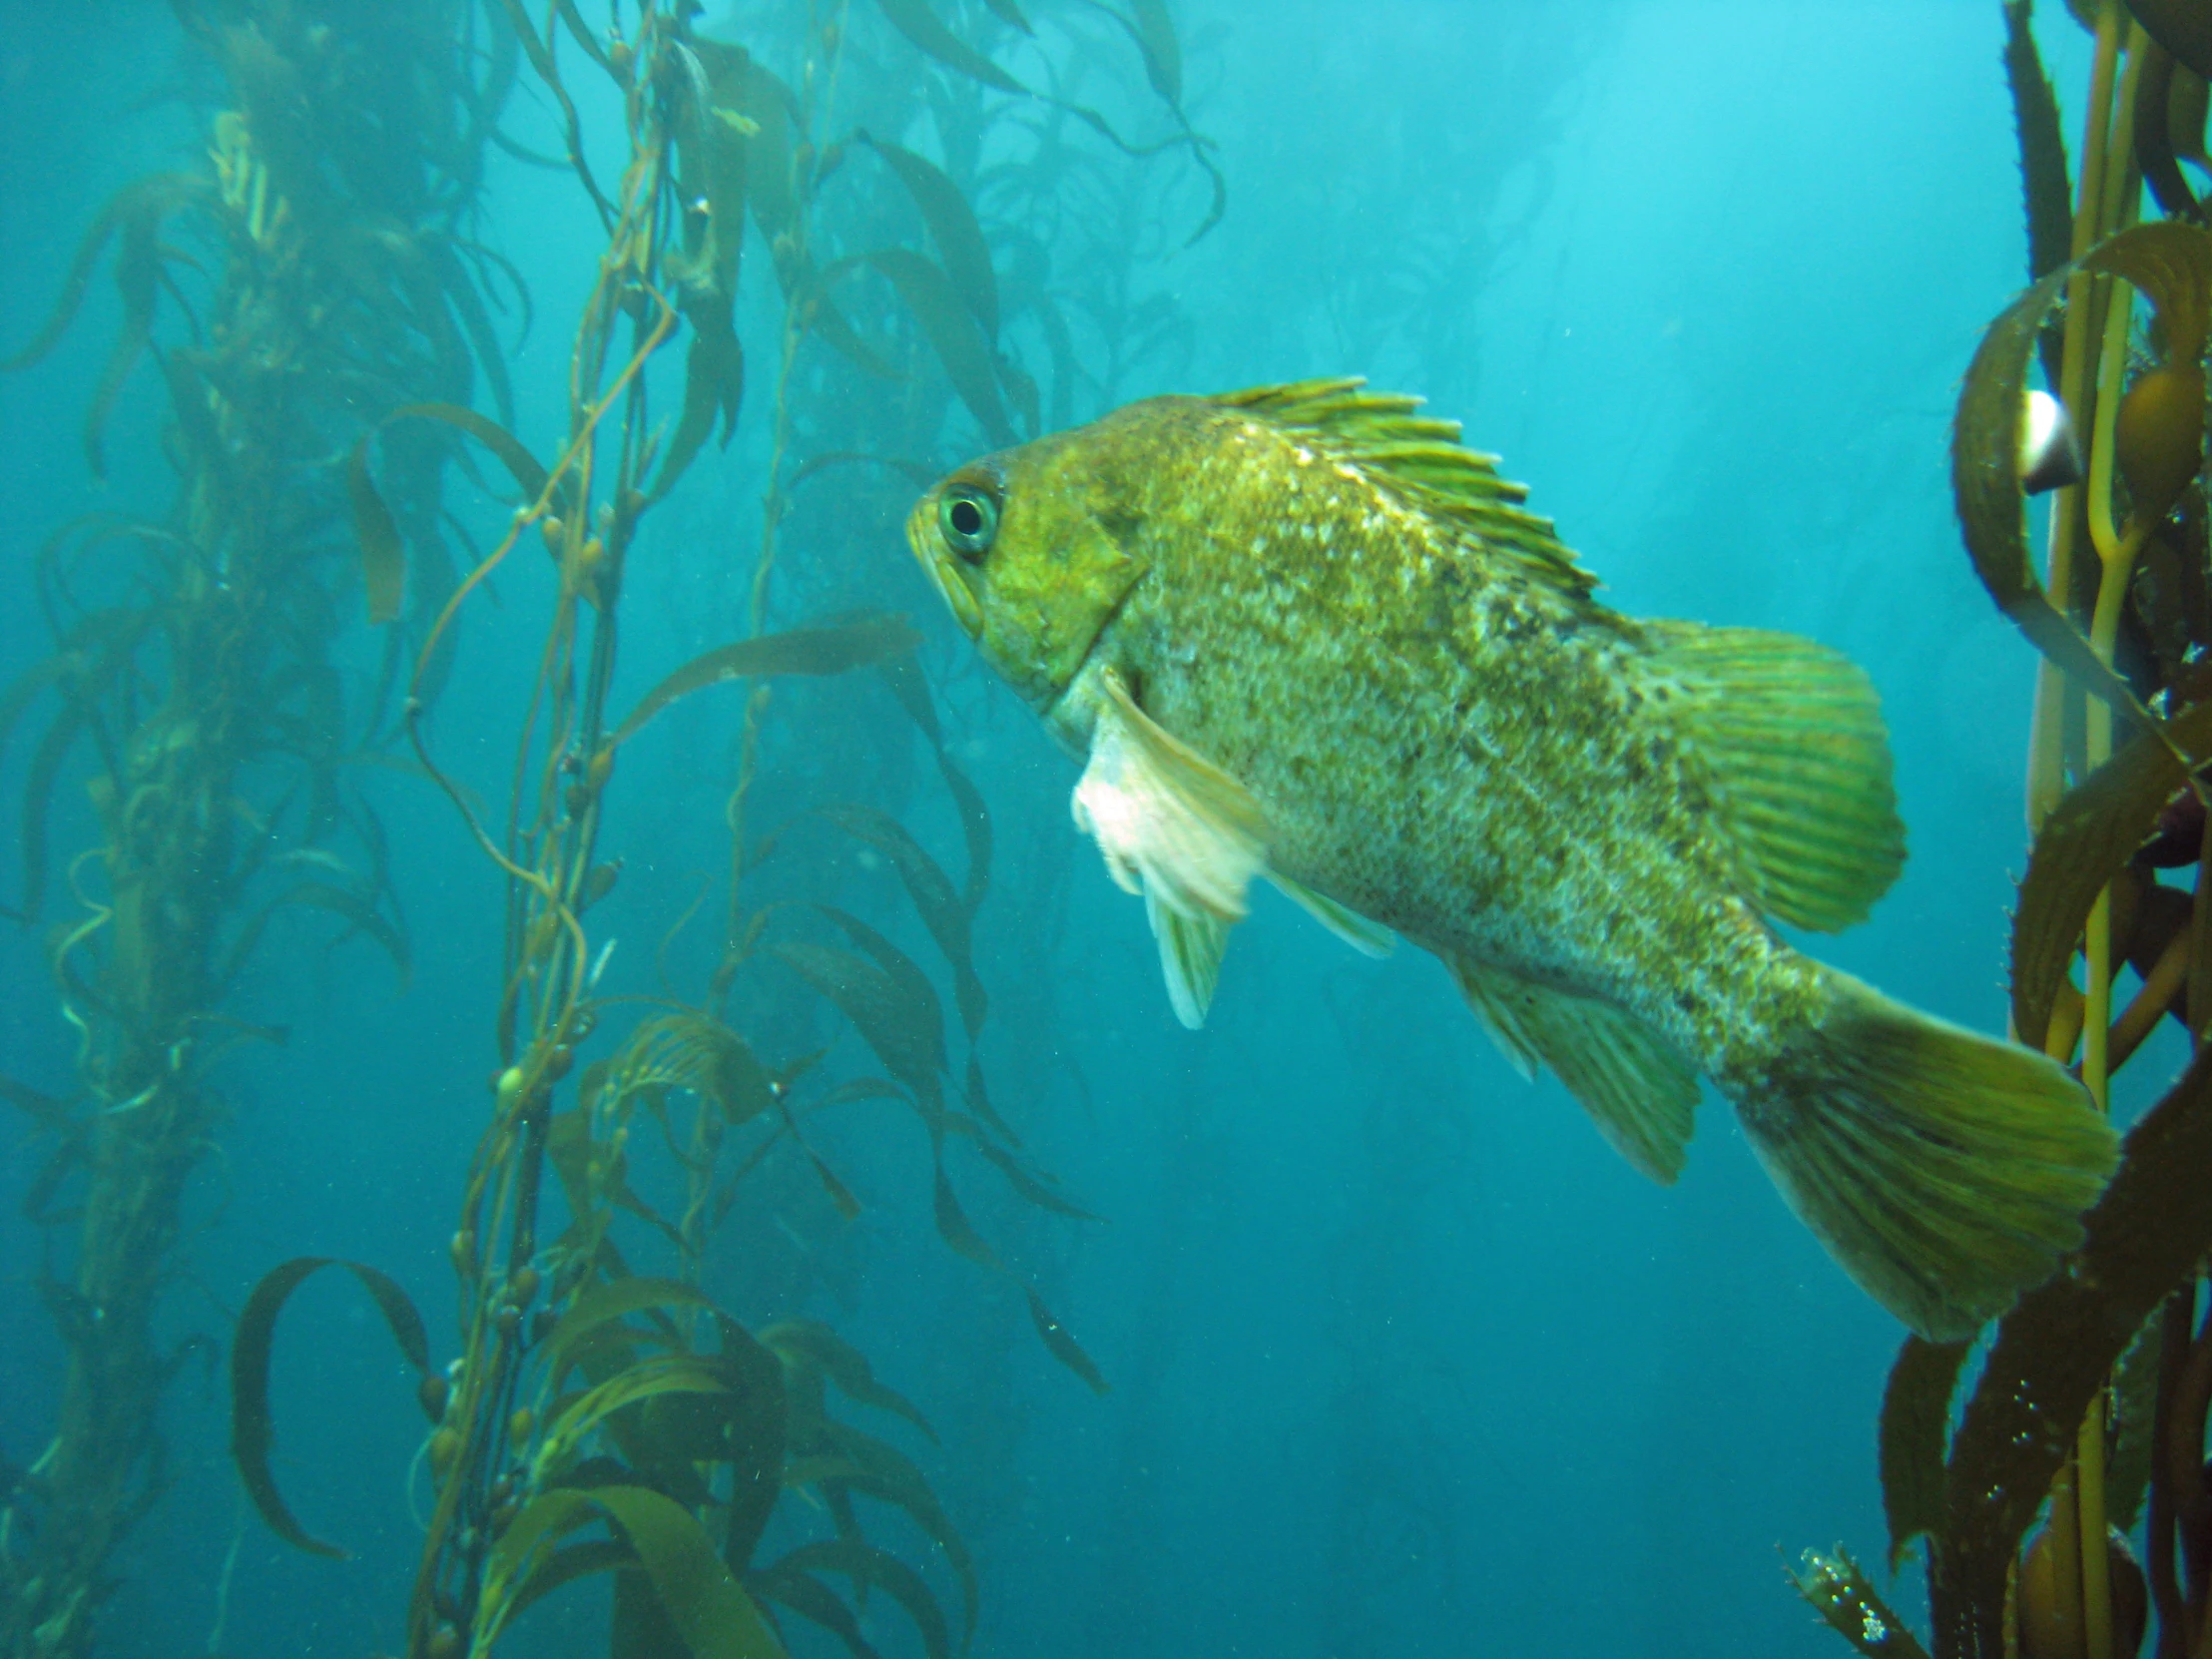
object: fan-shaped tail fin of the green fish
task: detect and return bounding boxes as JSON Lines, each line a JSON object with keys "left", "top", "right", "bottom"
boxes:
{"left": 1737, "top": 969, "right": 2119, "bottom": 1341}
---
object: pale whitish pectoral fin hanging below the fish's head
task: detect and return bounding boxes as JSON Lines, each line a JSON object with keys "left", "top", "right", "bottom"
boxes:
{"left": 1075, "top": 673, "right": 1268, "bottom": 1026}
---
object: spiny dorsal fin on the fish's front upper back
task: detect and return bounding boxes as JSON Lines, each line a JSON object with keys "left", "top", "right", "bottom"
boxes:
{"left": 1212, "top": 378, "right": 1597, "bottom": 600}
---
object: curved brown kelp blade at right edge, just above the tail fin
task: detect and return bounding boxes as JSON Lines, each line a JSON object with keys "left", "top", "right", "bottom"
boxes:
{"left": 2013, "top": 704, "right": 2212, "bottom": 1048}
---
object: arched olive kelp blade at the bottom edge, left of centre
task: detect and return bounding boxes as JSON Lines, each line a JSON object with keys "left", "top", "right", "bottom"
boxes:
{"left": 482, "top": 1486, "right": 783, "bottom": 1659}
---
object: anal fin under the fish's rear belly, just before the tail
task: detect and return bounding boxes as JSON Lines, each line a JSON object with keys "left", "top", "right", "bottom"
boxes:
{"left": 1451, "top": 962, "right": 1697, "bottom": 1186}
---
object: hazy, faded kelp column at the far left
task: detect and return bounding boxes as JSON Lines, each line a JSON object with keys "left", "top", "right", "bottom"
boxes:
{"left": 0, "top": 0, "right": 513, "bottom": 1659}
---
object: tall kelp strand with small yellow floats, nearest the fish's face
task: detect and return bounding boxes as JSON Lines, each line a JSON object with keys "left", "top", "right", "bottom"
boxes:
{"left": 203, "top": 0, "right": 1219, "bottom": 1659}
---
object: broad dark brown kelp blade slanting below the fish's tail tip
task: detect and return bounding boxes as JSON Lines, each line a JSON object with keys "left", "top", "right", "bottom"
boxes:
{"left": 1929, "top": 1048, "right": 2212, "bottom": 1652}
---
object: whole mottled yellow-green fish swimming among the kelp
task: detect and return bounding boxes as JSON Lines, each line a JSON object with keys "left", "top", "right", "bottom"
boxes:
{"left": 907, "top": 378, "right": 2117, "bottom": 1341}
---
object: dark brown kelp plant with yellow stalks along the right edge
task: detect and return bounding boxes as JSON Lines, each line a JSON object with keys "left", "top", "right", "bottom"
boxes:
{"left": 1792, "top": 0, "right": 2212, "bottom": 1659}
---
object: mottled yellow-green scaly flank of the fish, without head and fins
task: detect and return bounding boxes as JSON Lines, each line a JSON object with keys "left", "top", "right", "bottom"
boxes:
{"left": 1102, "top": 405, "right": 1819, "bottom": 1068}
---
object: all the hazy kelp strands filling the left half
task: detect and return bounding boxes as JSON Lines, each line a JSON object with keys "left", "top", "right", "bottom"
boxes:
{"left": 0, "top": 0, "right": 1226, "bottom": 1657}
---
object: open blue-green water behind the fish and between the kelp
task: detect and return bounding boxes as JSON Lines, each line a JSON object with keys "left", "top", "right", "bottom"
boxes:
{"left": 0, "top": 0, "right": 2157, "bottom": 1659}
